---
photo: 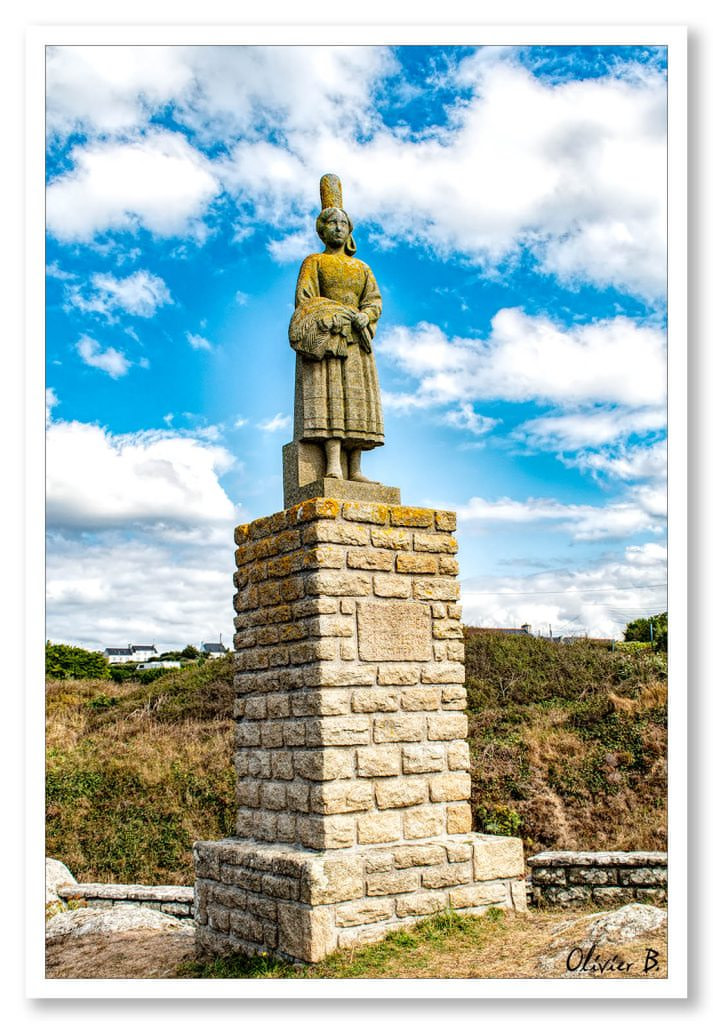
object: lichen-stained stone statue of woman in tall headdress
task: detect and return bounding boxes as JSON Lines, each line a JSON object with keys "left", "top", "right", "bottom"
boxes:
{"left": 289, "top": 174, "right": 384, "bottom": 482}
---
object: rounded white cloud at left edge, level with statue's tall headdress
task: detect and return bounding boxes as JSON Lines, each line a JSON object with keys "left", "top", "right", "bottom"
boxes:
{"left": 47, "top": 130, "right": 219, "bottom": 242}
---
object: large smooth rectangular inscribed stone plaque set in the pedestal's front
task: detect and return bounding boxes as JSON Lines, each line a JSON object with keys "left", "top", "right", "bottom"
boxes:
{"left": 357, "top": 598, "right": 431, "bottom": 662}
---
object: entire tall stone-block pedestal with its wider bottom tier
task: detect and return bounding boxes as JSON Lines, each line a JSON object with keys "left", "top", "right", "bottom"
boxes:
{"left": 195, "top": 498, "right": 526, "bottom": 963}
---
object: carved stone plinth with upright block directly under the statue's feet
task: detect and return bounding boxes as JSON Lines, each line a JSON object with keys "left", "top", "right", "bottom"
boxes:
{"left": 283, "top": 441, "right": 401, "bottom": 509}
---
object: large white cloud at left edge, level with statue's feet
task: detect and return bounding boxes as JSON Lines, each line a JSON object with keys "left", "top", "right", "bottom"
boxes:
{"left": 46, "top": 421, "right": 235, "bottom": 530}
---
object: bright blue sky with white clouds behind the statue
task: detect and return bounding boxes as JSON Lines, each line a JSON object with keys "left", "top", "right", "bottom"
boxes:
{"left": 46, "top": 46, "right": 675, "bottom": 647}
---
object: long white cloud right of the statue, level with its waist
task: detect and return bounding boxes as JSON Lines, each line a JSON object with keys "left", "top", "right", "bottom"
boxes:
{"left": 380, "top": 309, "right": 666, "bottom": 407}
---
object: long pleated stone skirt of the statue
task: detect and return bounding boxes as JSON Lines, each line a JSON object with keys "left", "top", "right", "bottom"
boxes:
{"left": 295, "top": 342, "right": 384, "bottom": 449}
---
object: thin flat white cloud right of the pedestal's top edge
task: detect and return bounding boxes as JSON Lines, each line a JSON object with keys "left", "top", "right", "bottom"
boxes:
{"left": 458, "top": 485, "right": 666, "bottom": 541}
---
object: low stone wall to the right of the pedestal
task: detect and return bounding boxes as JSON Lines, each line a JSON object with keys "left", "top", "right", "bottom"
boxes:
{"left": 528, "top": 850, "right": 668, "bottom": 906}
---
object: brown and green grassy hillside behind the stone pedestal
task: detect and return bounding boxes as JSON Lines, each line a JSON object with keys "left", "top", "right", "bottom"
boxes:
{"left": 46, "top": 630, "right": 666, "bottom": 885}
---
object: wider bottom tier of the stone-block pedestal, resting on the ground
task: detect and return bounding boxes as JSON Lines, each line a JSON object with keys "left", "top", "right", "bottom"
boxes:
{"left": 194, "top": 833, "right": 527, "bottom": 963}
